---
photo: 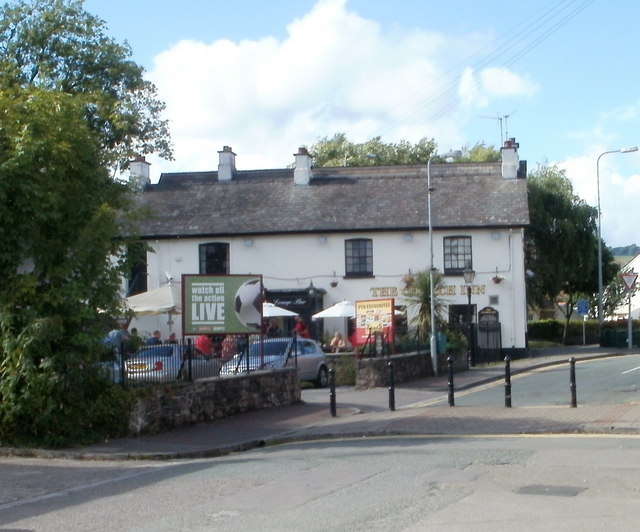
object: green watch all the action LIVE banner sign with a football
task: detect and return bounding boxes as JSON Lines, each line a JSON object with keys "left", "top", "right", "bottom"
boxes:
{"left": 182, "top": 274, "right": 262, "bottom": 335}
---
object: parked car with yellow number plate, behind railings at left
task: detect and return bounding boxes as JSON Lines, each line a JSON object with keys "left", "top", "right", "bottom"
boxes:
{"left": 124, "top": 344, "right": 224, "bottom": 382}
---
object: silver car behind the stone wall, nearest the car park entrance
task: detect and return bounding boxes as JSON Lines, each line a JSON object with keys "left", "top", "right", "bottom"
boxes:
{"left": 220, "top": 338, "right": 329, "bottom": 388}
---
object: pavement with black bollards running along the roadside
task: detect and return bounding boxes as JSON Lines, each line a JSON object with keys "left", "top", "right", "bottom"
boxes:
{"left": 5, "top": 346, "right": 640, "bottom": 460}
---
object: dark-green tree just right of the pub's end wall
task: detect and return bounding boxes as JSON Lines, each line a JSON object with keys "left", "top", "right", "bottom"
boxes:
{"left": 525, "top": 166, "right": 617, "bottom": 342}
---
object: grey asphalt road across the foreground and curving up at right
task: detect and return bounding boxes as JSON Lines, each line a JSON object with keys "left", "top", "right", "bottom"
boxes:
{"left": 0, "top": 356, "right": 640, "bottom": 532}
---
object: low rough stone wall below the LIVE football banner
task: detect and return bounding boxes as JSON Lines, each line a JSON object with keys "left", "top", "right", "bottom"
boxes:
{"left": 129, "top": 368, "right": 301, "bottom": 436}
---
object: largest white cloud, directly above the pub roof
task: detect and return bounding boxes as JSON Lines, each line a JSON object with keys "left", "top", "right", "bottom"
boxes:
{"left": 149, "top": 0, "right": 535, "bottom": 179}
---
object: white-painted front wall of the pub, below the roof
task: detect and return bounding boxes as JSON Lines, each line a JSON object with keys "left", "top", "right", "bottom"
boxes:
{"left": 131, "top": 229, "right": 526, "bottom": 348}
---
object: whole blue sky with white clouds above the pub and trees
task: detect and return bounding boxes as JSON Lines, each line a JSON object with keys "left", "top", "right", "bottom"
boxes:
{"left": 84, "top": 0, "right": 640, "bottom": 247}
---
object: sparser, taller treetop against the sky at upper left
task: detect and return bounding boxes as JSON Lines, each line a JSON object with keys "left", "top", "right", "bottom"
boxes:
{"left": 0, "top": 0, "right": 171, "bottom": 169}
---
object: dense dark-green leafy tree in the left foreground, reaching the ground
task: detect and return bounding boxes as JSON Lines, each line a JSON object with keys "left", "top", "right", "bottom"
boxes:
{"left": 0, "top": 88, "right": 128, "bottom": 446}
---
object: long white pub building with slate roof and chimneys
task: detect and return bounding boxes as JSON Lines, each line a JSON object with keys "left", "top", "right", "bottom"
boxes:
{"left": 127, "top": 139, "right": 529, "bottom": 355}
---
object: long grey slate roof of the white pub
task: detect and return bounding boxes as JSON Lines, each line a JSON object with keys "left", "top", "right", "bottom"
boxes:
{"left": 130, "top": 163, "right": 529, "bottom": 238}
